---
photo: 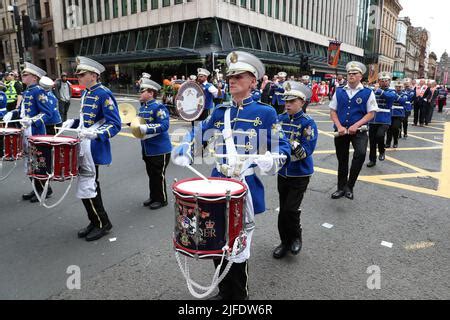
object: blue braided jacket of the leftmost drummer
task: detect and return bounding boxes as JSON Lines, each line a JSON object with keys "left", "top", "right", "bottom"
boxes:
{"left": 12, "top": 84, "right": 53, "bottom": 135}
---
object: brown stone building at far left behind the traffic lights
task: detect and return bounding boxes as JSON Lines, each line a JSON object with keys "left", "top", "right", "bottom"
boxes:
{"left": 0, "top": 0, "right": 58, "bottom": 78}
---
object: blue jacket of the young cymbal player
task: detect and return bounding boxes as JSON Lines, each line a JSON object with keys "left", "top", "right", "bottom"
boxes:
{"left": 139, "top": 100, "right": 172, "bottom": 156}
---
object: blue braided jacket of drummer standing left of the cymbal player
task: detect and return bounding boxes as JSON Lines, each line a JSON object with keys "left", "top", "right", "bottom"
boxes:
{"left": 72, "top": 83, "right": 122, "bottom": 165}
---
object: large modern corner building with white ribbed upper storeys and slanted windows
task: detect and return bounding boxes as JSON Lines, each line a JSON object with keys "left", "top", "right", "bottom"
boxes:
{"left": 52, "top": 0, "right": 369, "bottom": 80}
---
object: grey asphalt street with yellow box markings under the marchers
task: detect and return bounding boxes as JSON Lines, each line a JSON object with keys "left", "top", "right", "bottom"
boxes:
{"left": 0, "top": 99, "right": 450, "bottom": 300}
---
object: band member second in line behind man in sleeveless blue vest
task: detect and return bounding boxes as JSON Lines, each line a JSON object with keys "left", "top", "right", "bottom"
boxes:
{"left": 386, "top": 81, "right": 408, "bottom": 149}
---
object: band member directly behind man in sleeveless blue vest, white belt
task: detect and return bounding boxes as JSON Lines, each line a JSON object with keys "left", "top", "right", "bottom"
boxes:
{"left": 367, "top": 72, "right": 397, "bottom": 168}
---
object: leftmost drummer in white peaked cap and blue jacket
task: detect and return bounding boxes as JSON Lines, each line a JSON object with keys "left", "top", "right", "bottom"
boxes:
{"left": 3, "top": 62, "right": 53, "bottom": 203}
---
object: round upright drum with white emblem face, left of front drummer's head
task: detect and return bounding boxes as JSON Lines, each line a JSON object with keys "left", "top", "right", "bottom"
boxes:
{"left": 174, "top": 81, "right": 205, "bottom": 121}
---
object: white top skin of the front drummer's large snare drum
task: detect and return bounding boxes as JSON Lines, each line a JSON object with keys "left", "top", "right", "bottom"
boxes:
{"left": 173, "top": 178, "right": 247, "bottom": 197}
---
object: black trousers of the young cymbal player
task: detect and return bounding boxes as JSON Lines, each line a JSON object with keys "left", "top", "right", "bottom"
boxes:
{"left": 142, "top": 153, "right": 170, "bottom": 203}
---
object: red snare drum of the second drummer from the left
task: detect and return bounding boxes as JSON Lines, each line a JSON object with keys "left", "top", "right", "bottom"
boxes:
{"left": 28, "top": 135, "right": 80, "bottom": 181}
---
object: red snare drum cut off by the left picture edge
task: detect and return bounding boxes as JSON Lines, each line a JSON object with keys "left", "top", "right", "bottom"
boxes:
{"left": 0, "top": 128, "right": 23, "bottom": 161}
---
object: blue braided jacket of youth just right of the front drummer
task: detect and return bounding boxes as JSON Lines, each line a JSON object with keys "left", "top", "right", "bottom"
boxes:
{"left": 278, "top": 111, "right": 319, "bottom": 177}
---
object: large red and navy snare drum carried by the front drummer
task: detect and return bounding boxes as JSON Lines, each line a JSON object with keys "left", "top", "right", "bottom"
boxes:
{"left": 172, "top": 178, "right": 247, "bottom": 259}
